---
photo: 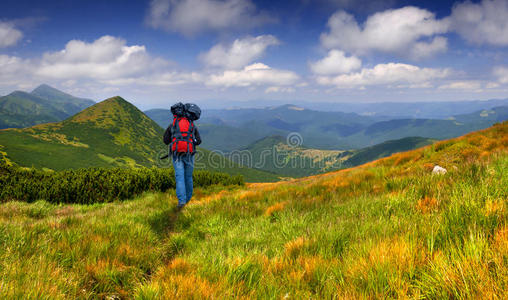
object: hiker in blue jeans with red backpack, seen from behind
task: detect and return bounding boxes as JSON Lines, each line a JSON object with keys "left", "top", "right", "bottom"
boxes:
{"left": 164, "top": 102, "right": 201, "bottom": 210}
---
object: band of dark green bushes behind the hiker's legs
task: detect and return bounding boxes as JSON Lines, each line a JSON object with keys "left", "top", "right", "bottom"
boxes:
{"left": 0, "top": 164, "right": 243, "bottom": 204}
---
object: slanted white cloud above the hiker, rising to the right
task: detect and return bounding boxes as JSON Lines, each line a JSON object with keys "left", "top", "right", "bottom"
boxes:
{"left": 199, "top": 35, "right": 279, "bottom": 69}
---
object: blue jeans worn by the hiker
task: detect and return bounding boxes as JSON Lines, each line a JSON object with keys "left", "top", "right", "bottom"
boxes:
{"left": 173, "top": 155, "right": 194, "bottom": 205}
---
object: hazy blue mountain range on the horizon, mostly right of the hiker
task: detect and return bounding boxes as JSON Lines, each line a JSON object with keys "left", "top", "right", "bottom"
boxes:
{"left": 145, "top": 105, "right": 508, "bottom": 152}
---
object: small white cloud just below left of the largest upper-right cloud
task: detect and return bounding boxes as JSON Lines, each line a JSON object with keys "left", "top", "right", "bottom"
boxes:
{"left": 309, "top": 50, "right": 362, "bottom": 75}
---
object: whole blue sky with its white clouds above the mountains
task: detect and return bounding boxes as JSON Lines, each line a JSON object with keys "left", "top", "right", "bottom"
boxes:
{"left": 0, "top": 0, "right": 508, "bottom": 109}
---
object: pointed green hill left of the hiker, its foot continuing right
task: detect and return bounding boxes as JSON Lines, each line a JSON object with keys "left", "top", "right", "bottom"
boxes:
{"left": 0, "top": 97, "right": 278, "bottom": 181}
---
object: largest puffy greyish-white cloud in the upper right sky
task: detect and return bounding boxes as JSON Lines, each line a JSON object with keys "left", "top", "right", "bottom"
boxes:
{"left": 321, "top": 6, "right": 449, "bottom": 55}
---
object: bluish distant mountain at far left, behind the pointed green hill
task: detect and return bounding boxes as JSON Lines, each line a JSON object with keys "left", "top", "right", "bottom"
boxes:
{"left": 0, "top": 84, "right": 95, "bottom": 129}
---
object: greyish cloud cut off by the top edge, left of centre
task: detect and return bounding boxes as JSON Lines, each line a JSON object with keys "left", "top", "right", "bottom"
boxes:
{"left": 146, "top": 0, "right": 274, "bottom": 36}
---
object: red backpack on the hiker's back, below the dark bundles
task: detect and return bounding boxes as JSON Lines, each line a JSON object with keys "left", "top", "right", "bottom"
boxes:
{"left": 169, "top": 115, "right": 194, "bottom": 154}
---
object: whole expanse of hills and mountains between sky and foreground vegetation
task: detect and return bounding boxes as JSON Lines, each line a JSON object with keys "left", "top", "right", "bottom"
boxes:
{"left": 0, "top": 84, "right": 508, "bottom": 182}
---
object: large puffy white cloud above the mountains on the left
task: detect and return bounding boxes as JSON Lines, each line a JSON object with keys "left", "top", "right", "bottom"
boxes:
{"left": 36, "top": 36, "right": 168, "bottom": 80}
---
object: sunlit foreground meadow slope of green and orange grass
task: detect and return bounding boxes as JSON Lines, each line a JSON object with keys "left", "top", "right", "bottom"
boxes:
{"left": 0, "top": 122, "right": 508, "bottom": 299}
